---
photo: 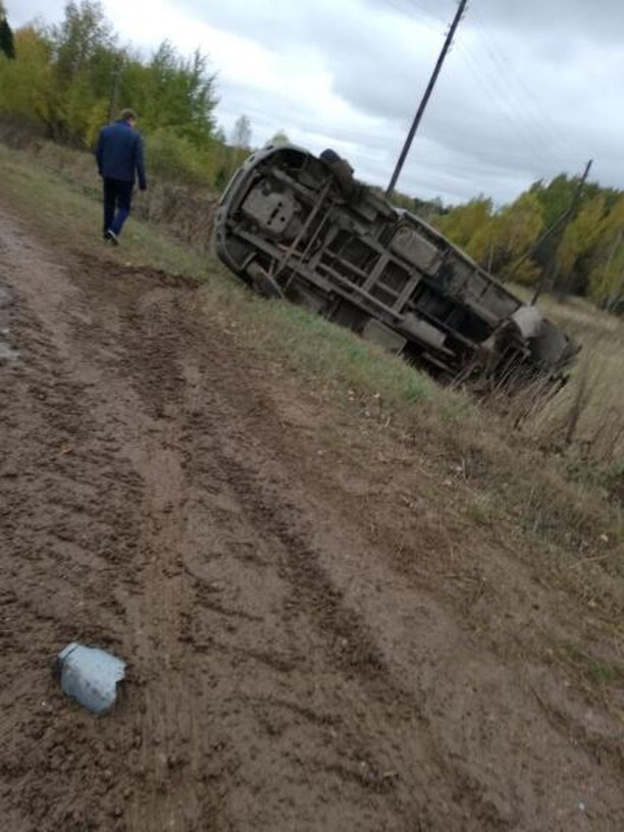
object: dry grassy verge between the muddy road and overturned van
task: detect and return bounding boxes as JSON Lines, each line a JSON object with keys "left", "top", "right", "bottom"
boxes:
{"left": 0, "top": 145, "right": 624, "bottom": 635}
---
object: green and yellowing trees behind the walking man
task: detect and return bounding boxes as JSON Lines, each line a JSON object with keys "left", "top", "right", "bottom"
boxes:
{"left": 0, "top": 0, "right": 256, "bottom": 186}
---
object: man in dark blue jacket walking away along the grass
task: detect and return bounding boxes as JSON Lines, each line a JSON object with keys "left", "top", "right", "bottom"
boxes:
{"left": 95, "top": 110, "right": 147, "bottom": 245}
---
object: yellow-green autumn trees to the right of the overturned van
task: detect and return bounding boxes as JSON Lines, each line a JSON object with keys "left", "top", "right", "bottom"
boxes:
{"left": 433, "top": 174, "right": 624, "bottom": 309}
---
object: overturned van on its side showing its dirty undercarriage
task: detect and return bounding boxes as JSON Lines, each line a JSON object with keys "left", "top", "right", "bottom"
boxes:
{"left": 216, "top": 145, "right": 578, "bottom": 384}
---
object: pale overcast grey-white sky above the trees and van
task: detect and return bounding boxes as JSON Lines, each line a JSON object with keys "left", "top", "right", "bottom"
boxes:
{"left": 5, "top": 0, "right": 624, "bottom": 203}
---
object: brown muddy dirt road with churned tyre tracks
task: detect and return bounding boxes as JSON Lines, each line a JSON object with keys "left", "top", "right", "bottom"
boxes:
{"left": 0, "top": 203, "right": 624, "bottom": 832}
